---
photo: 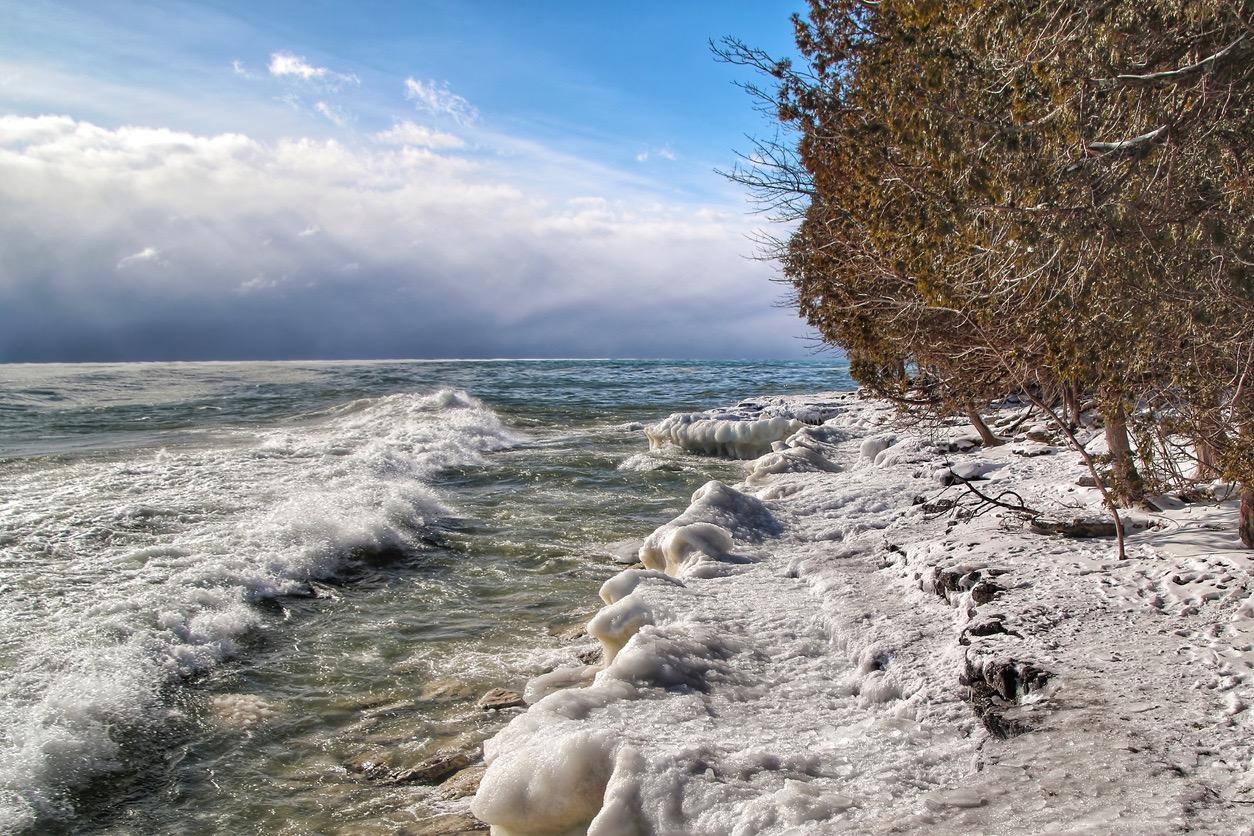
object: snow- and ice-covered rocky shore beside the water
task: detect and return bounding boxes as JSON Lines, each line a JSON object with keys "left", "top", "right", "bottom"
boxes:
{"left": 473, "top": 395, "right": 1254, "bottom": 836}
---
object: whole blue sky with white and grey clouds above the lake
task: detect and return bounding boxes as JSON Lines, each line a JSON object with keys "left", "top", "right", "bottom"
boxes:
{"left": 0, "top": 0, "right": 815, "bottom": 362}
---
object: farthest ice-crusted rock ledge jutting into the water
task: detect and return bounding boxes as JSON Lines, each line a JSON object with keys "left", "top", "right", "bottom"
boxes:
{"left": 645, "top": 397, "right": 836, "bottom": 459}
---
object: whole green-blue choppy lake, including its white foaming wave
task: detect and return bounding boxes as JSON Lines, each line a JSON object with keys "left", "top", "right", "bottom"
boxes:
{"left": 0, "top": 360, "right": 850, "bottom": 833}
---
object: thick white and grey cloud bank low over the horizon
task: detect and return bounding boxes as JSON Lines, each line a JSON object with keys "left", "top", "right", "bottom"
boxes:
{"left": 0, "top": 113, "right": 805, "bottom": 361}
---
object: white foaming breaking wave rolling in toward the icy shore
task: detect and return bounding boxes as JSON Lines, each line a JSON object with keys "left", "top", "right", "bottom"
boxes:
{"left": 0, "top": 390, "right": 520, "bottom": 832}
